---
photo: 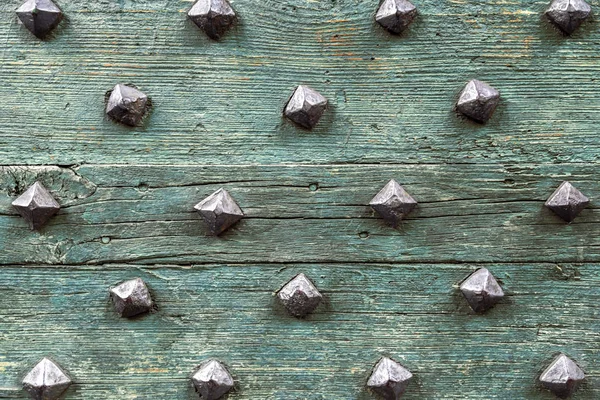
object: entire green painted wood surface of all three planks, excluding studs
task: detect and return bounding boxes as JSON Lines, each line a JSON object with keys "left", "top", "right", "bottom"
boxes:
{"left": 0, "top": 0, "right": 600, "bottom": 400}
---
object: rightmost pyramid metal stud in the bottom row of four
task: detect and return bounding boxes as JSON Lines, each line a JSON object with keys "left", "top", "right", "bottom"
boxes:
{"left": 540, "top": 354, "right": 585, "bottom": 398}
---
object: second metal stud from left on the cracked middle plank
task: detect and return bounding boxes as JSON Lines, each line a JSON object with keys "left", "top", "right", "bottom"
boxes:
{"left": 194, "top": 188, "right": 244, "bottom": 235}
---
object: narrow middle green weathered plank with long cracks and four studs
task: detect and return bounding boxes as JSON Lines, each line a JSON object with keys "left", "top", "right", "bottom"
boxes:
{"left": 0, "top": 164, "right": 600, "bottom": 264}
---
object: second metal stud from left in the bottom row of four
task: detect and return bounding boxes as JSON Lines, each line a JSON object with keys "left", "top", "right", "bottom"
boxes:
{"left": 192, "top": 360, "right": 233, "bottom": 400}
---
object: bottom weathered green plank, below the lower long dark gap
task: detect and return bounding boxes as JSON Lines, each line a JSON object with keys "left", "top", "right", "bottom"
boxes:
{"left": 0, "top": 264, "right": 600, "bottom": 400}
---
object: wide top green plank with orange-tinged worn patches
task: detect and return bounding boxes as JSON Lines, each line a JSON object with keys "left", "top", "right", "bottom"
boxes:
{"left": 0, "top": 0, "right": 600, "bottom": 165}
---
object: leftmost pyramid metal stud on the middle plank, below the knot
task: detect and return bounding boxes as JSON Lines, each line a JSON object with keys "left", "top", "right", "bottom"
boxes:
{"left": 12, "top": 182, "right": 60, "bottom": 229}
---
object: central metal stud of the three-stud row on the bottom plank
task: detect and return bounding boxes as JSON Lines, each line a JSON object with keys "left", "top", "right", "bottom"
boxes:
{"left": 277, "top": 274, "right": 323, "bottom": 318}
